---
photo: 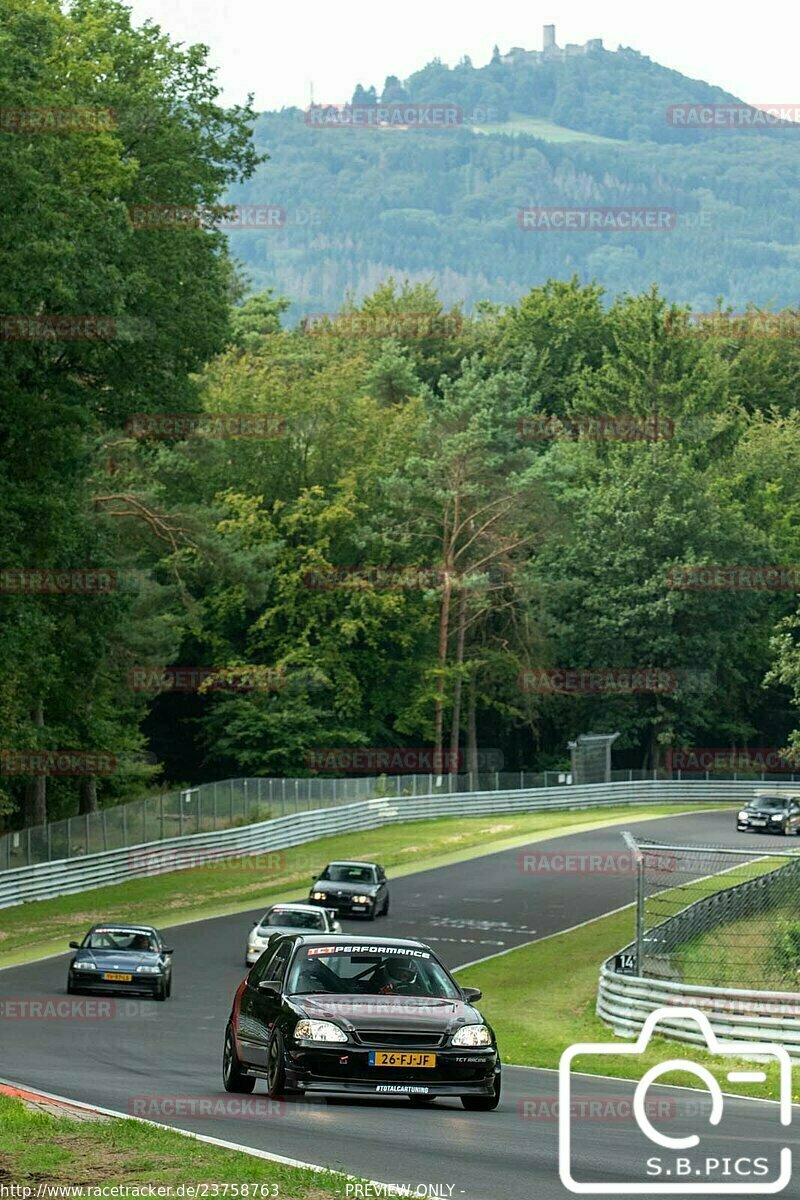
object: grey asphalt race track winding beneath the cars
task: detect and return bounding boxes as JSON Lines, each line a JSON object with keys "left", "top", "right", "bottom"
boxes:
{"left": 0, "top": 810, "right": 800, "bottom": 1200}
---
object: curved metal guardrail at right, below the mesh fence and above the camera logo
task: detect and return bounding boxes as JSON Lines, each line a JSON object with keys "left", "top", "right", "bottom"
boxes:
{"left": 597, "top": 959, "right": 800, "bottom": 1060}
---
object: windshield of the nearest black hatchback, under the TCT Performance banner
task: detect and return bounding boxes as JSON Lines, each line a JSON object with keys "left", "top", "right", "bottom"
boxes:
{"left": 287, "top": 946, "right": 461, "bottom": 1000}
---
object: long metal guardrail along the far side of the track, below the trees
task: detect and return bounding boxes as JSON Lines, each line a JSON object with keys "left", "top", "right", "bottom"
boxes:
{"left": 0, "top": 780, "right": 777, "bottom": 908}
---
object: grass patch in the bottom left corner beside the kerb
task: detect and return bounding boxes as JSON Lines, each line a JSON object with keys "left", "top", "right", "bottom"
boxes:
{"left": 0, "top": 1096, "right": 345, "bottom": 1200}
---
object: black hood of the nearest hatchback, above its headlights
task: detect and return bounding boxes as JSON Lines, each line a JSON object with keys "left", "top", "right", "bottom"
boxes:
{"left": 287, "top": 992, "right": 483, "bottom": 1033}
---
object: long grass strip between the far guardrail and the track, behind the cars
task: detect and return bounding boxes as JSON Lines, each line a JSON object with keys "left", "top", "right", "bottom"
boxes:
{"left": 0, "top": 804, "right": 729, "bottom": 966}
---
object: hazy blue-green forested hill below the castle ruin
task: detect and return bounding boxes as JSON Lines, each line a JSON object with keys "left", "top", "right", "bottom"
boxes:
{"left": 229, "top": 50, "right": 800, "bottom": 319}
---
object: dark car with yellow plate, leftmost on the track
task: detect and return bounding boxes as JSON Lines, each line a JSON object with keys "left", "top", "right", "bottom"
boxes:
{"left": 67, "top": 922, "right": 173, "bottom": 1000}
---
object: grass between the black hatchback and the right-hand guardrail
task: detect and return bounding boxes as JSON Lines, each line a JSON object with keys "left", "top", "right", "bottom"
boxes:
{"left": 458, "top": 880, "right": 800, "bottom": 1102}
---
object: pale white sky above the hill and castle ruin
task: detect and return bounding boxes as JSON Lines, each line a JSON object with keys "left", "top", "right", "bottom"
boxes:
{"left": 125, "top": 0, "right": 800, "bottom": 108}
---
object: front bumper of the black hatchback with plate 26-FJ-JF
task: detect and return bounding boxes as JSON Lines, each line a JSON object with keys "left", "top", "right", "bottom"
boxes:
{"left": 285, "top": 1043, "right": 500, "bottom": 1096}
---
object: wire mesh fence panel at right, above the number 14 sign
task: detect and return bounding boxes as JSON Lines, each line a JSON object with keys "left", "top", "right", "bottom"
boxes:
{"left": 627, "top": 835, "right": 800, "bottom": 991}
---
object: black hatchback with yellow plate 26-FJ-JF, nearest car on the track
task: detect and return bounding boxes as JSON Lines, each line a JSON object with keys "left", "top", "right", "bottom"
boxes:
{"left": 222, "top": 934, "right": 500, "bottom": 1111}
